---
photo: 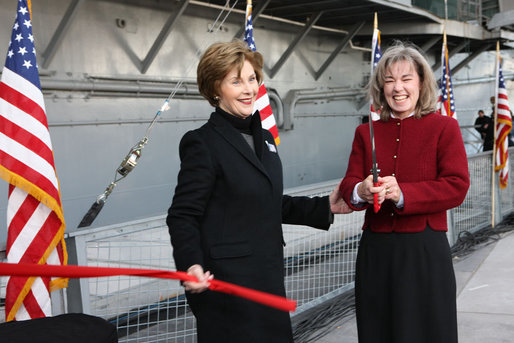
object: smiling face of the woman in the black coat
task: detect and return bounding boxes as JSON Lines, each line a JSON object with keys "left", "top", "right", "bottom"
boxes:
{"left": 218, "top": 61, "right": 259, "bottom": 118}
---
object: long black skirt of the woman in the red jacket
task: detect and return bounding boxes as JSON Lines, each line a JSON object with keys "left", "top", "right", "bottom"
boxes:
{"left": 355, "top": 227, "right": 458, "bottom": 343}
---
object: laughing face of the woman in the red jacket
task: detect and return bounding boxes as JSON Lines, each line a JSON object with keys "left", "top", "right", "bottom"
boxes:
{"left": 384, "top": 61, "right": 421, "bottom": 119}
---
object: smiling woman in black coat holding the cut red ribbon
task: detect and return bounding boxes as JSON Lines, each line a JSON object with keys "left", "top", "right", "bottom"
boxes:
{"left": 167, "top": 41, "right": 351, "bottom": 343}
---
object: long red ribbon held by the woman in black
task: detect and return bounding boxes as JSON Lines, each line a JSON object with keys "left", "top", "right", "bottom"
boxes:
{"left": 0, "top": 263, "right": 296, "bottom": 312}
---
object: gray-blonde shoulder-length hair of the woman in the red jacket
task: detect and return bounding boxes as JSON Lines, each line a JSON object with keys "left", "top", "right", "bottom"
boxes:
{"left": 368, "top": 42, "right": 437, "bottom": 121}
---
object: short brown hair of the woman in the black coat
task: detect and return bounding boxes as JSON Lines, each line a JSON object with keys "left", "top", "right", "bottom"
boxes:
{"left": 196, "top": 40, "right": 263, "bottom": 106}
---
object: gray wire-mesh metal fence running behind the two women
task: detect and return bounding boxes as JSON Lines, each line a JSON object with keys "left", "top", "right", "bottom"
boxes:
{"left": 0, "top": 148, "right": 514, "bottom": 343}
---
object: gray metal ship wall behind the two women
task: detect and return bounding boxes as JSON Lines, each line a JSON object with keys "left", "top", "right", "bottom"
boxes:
{"left": 0, "top": 0, "right": 514, "bottom": 242}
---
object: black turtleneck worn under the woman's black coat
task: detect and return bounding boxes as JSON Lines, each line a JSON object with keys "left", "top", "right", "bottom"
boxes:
{"left": 216, "top": 107, "right": 262, "bottom": 159}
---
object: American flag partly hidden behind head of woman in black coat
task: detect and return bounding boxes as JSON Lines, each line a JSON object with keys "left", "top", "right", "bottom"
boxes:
{"left": 244, "top": 3, "right": 280, "bottom": 145}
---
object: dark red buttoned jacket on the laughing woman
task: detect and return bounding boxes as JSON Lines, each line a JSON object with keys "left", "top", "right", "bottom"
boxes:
{"left": 339, "top": 113, "right": 469, "bottom": 232}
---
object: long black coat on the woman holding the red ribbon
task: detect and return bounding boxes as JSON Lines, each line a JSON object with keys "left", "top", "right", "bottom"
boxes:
{"left": 167, "top": 112, "right": 332, "bottom": 343}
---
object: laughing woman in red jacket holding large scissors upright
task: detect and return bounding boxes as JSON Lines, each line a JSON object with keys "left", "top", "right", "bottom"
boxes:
{"left": 339, "top": 43, "right": 469, "bottom": 343}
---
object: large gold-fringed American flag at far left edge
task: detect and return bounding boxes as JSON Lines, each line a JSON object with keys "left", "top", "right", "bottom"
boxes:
{"left": 0, "top": 0, "right": 67, "bottom": 321}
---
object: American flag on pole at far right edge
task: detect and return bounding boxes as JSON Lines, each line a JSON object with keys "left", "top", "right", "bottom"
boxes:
{"left": 495, "top": 57, "right": 512, "bottom": 188}
